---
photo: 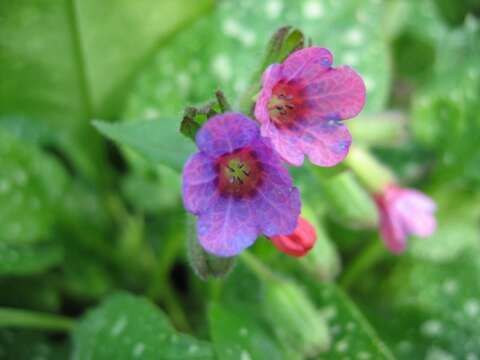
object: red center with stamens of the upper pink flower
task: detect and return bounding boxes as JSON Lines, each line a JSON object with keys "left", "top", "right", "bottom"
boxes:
{"left": 268, "top": 81, "right": 302, "bottom": 127}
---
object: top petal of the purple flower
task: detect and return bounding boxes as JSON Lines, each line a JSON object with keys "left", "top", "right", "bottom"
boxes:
{"left": 196, "top": 112, "right": 259, "bottom": 157}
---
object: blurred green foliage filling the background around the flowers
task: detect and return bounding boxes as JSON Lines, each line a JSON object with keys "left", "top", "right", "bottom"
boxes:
{"left": 0, "top": 0, "right": 480, "bottom": 360}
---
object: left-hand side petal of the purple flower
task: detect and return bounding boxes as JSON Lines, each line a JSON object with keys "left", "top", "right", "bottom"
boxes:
{"left": 182, "top": 153, "right": 219, "bottom": 214}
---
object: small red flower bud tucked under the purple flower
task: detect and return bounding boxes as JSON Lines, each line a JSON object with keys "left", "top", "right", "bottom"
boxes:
{"left": 270, "top": 217, "right": 317, "bottom": 256}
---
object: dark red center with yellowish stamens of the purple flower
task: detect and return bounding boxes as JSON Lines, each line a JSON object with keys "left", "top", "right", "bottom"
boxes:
{"left": 217, "top": 148, "right": 262, "bottom": 198}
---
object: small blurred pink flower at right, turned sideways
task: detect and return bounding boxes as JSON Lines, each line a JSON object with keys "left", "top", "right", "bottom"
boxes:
{"left": 375, "top": 185, "right": 437, "bottom": 253}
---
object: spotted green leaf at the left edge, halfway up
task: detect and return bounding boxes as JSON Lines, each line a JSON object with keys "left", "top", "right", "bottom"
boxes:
{"left": 0, "top": 129, "right": 66, "bottom": 244}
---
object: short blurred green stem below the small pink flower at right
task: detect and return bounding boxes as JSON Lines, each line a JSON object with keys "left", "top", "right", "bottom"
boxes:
{"left": 340, "top": 239, "right": 387, "bottom": 289}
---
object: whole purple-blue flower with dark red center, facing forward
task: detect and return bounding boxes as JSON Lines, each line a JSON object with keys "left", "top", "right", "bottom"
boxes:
{"left": 182, "top": 113, "right": 300, "bottom": 257}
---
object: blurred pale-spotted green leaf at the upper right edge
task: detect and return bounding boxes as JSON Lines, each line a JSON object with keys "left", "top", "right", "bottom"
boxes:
{"left": 412, "top": 17, "right": 480, "bottom": 186}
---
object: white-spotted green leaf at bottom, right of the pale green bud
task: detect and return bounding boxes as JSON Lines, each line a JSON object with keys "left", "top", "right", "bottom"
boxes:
{"left": 307, "top": 280, "right": 394, "bottom": 360}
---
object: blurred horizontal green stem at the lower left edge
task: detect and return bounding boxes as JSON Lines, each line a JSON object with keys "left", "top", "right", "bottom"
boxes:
{"left": 0, "top": 308, "right": 75, "bottom": 332}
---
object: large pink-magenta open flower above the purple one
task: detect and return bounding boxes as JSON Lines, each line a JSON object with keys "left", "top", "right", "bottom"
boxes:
{"left": 255, "top": 47, "right": 365, "bottom": 166}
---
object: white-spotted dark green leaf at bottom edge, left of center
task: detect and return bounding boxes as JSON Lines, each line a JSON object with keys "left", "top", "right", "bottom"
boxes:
{"left": 72, "top": 293, "right": 214, "bottom": 360}
